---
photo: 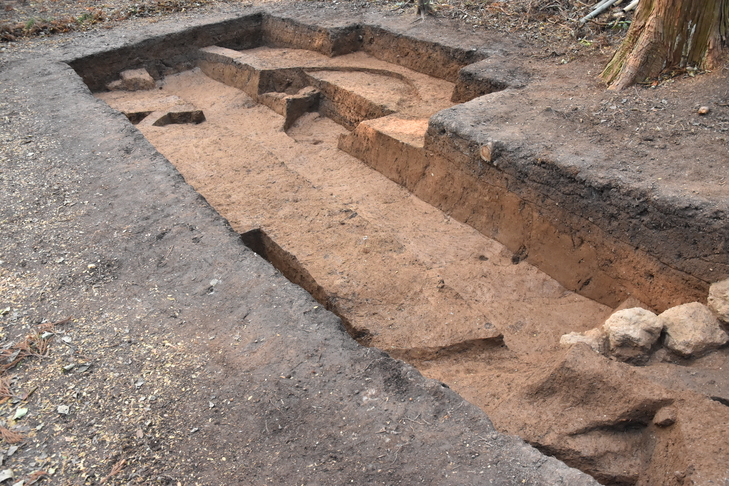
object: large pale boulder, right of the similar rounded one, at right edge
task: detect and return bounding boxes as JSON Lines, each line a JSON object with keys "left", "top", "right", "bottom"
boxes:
{"left": 658, "top": 302, "right": 729, "bottom": 357}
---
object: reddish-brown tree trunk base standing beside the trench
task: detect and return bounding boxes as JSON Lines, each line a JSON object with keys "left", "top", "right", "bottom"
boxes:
{"left": 600, "top": 0, "right": 729, "bottom": 90}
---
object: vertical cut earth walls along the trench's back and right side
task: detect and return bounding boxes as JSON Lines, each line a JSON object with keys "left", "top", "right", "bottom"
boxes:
{"left": 70, "top": 13, "right": 729, "bottom": 316}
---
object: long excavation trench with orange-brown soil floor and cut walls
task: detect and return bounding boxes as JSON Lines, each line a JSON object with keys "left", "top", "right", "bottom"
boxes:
{"left": 79, "top": 14, "right": 729, "bottom": 484}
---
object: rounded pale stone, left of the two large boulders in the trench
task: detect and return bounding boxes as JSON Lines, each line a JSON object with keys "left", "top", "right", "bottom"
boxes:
{"left": 602, "top": 307, "right": 663, "bottom": 364}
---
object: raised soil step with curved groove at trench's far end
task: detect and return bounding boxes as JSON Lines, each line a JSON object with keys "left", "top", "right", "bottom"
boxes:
{"left": 198, "top": 46, "right": 455, "bottom": 130}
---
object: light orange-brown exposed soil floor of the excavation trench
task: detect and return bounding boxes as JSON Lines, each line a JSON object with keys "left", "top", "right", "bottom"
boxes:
{"left": 97, "top": 43, "right": 729, "bottom": 484}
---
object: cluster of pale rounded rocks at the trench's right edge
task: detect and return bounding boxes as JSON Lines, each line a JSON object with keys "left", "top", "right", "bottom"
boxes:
{"left": 560, "top": 279, "right": 729, "bottom": 364}
